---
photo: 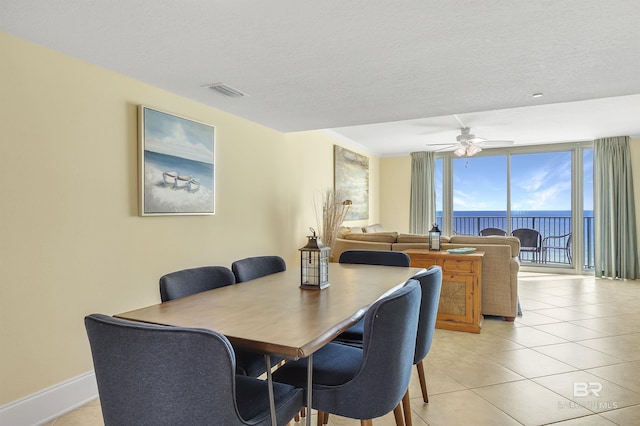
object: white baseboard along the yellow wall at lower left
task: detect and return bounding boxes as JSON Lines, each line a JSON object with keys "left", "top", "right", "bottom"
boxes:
{"left": 0, "top": 371, "right": 98, "bottom": 426}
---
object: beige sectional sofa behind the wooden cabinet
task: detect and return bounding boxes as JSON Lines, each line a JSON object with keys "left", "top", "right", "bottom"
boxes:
{"left": 332, "top": 225, "right": 520, "bottom": 320}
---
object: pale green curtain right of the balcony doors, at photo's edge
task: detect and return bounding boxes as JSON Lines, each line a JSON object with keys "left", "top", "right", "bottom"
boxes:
{"left": 593, "top": 136, "right": 639, "bottom": 279}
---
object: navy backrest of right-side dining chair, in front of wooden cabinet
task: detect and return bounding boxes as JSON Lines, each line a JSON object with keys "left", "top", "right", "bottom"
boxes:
{"left": 413, "top": 266, "right": 442, "bottom": 364}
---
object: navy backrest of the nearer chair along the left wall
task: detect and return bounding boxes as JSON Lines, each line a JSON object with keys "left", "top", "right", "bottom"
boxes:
{"left": 160, "top": 266, "right": 236, "bottom": 302}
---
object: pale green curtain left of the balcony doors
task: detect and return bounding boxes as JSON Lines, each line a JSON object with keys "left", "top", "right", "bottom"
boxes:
{"left": 409, "top": 151, "right": 436, "bottom": 234}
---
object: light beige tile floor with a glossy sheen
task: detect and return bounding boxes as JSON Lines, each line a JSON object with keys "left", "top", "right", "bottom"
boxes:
{"left": 48, "top": 273, "right": 640, "bottom": 426}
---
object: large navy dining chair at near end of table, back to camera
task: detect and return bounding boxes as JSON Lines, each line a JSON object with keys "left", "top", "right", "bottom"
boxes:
{"left": 85, "top": 314, "right": 303, "bottom": 426}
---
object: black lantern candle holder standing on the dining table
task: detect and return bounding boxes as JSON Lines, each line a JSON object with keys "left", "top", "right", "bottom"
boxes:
{"left": 300, "top": 228, "right": 330, "bottom": 290}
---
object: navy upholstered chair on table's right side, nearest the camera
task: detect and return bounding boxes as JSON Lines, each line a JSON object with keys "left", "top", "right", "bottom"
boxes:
{"left": 273, "top": 280, "right": 420, "bottom": 424}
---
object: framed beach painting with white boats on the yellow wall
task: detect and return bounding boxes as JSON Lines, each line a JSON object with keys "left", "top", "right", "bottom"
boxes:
{"left": 139, "top": 105, "right": 215, "bottom": 216}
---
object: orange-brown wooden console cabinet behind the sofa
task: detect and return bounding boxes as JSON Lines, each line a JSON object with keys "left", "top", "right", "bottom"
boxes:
{"left": 405, "top": 249, "right": 484, "bottom": 333}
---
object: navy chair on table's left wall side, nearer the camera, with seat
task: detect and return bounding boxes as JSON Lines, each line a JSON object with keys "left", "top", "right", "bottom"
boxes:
{"left": 160, "top": 266, "right": 282, "bottom": 377}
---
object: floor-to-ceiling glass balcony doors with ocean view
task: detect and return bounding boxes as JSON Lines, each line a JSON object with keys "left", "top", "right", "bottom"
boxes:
{"left": 435, "top": 144, "right": 593, "bottom": 272}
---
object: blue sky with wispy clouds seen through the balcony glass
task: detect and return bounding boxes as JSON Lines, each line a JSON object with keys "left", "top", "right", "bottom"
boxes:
{"left": 436, "top": 150, "right": 593, "bottom": 211}
